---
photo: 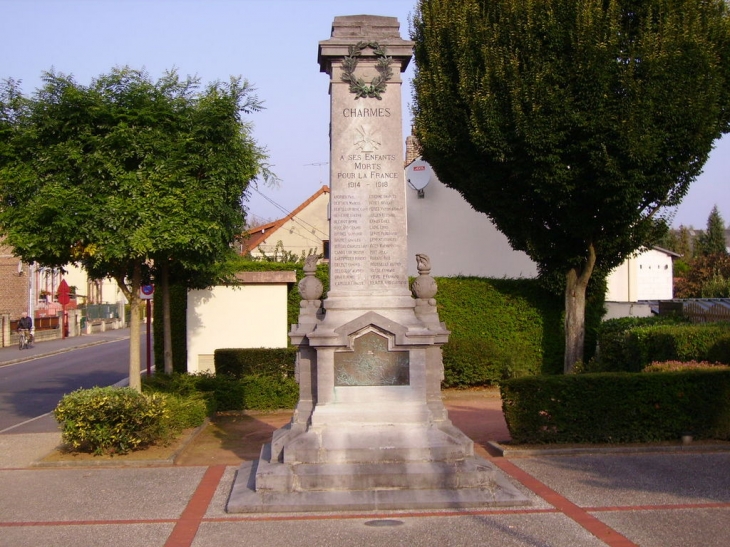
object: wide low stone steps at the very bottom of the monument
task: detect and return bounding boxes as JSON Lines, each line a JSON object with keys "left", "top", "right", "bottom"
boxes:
{"left": 226, "top": 456, "right": 530, "bottom": 513}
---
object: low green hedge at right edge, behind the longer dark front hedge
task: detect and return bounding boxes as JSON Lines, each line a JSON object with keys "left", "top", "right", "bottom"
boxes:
{"left": 589, "top": 318, "right": 730, "bottom": 372}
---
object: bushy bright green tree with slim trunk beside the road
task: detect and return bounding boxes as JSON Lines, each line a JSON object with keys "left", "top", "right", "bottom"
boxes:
{"left": 0, "top": 67, "right": 266, "bottom": 389}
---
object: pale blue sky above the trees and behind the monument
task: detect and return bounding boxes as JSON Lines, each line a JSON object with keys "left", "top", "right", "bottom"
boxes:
{"left": 0, "top": 0, "right": 730, "bottom": 228}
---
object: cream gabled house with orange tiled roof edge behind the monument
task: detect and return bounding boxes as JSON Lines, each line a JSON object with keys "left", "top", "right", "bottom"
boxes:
{"left": 238, "top": 186, "right": 330, "bottom": 261}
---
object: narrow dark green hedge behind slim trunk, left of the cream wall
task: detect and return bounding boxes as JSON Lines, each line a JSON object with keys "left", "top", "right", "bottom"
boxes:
{"left": 153, "top": 284, "right": 188, "bottom": 372}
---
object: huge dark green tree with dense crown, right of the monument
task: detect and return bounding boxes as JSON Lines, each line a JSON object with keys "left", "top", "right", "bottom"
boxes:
{"left": 412, "top": 0, "right": 730, "bottom": 372}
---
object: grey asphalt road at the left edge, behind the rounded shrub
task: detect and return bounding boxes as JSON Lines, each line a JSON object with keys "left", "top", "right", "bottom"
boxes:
{"left": 0, "top": 337, "right": 145, "bottom": 433}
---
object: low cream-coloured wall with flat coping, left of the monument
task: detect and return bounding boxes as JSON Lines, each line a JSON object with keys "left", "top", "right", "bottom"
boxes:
{"left": 187, "top": 271, "right": 296, "bottom": 373}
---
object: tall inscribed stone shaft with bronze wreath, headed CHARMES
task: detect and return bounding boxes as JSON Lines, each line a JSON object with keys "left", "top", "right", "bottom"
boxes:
{"left": 319, "top": 16, "right": 413, "bottom": 306}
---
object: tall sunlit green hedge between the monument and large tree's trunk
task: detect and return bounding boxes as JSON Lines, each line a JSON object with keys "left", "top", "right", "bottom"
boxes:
{"left": 436, "top": 277, "right": 563, "bottom": 378}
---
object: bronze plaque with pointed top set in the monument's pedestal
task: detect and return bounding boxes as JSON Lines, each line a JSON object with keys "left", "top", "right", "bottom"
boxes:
{"left": 335, "top": 332, "right": 410, "bottom": 386}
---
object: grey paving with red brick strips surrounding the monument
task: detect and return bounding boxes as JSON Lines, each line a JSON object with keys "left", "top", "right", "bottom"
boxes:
{"left": 0, "top": 333, "right": 730, "bottom": 547}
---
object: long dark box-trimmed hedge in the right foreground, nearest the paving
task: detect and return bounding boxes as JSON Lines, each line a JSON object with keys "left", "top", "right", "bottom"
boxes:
{"left": 500, "top": 370, "right": 730, "bottom": 443}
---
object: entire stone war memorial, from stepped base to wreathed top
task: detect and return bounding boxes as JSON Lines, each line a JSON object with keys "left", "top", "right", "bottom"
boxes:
{"left": 227, "top": 16, "right": 526, "bottom": 512}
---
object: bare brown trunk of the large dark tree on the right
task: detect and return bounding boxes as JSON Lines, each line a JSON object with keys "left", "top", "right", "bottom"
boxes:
{"left": 563, "top": 244, "right": 596, "bottom": 374}
